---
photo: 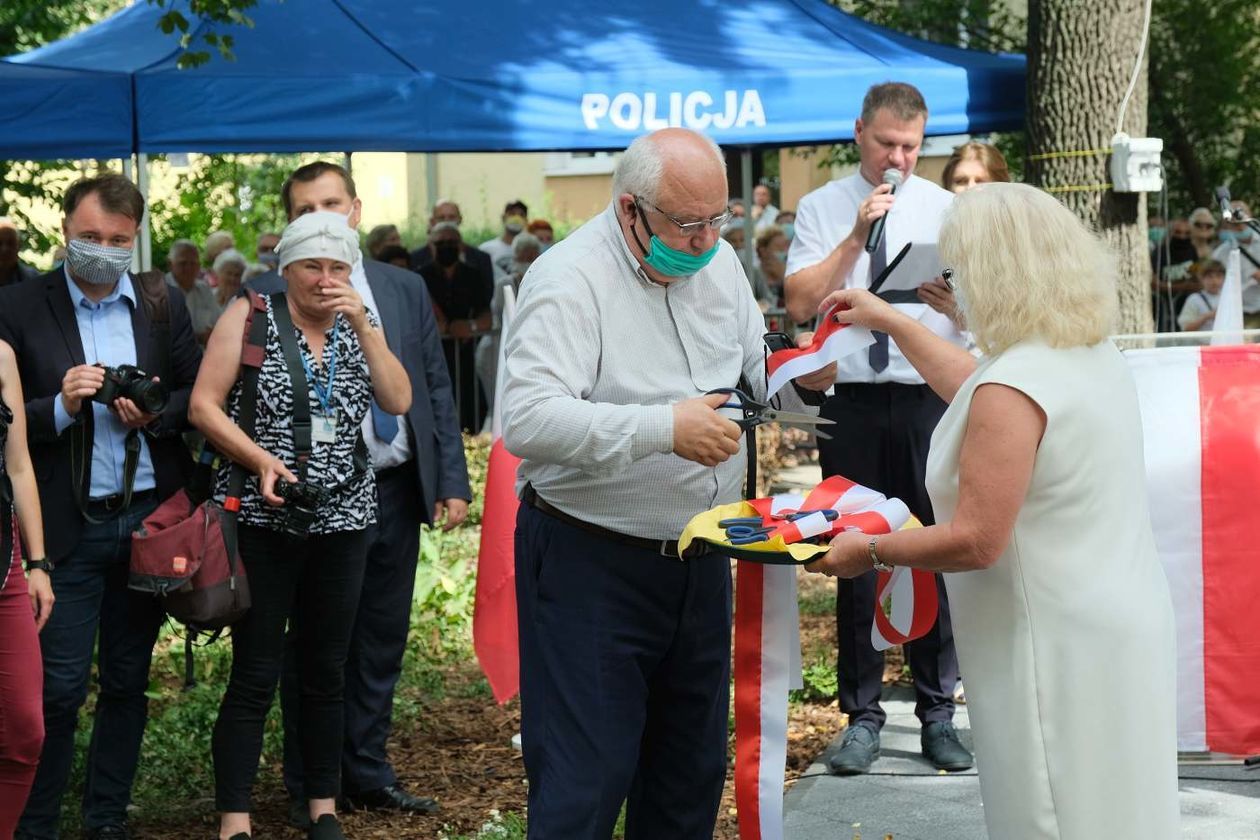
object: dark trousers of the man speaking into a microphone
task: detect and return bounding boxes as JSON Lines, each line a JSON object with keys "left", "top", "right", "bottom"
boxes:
{"left": 818, "top": 383, "right": 958, "bottom": 729}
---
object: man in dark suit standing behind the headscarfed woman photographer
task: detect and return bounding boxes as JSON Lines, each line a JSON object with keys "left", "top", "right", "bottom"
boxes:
{"left": 251, "top": 161, "right": 473, "bottom": 824}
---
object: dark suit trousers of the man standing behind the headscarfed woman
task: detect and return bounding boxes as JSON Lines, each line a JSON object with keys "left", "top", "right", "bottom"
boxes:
{"left": 280, "top": 462, "right": 426, "bottom": 800}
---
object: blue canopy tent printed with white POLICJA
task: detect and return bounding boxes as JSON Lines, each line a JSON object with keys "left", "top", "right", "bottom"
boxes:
{"left": 0, "top": 0, "right": 1024, "bottom": 157}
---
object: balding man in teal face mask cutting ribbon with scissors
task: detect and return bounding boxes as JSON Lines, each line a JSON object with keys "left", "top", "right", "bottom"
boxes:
{"left": 503, "top": 128, "right": 834, "bottom": 840}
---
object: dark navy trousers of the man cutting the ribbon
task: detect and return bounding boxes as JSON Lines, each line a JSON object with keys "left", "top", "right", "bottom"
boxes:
{"left": 515, "top": 505, "right": 731, "bottom": 840}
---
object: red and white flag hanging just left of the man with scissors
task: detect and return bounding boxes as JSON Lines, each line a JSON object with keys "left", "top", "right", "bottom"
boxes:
{"left": 473, "top": 286, "right": 520, "bottom": 703}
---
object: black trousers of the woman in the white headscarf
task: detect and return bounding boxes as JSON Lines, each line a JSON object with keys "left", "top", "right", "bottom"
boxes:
{"left": 213, "top": 525, "right": 367, "bottom": 811}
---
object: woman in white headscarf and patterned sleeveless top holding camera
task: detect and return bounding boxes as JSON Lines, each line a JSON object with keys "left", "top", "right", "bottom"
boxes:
{"left": 190, "top": 212, "right": 411, "bottom": 840}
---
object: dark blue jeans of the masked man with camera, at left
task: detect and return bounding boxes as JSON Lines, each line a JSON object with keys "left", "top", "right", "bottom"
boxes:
{"left": 18, "top": 499, "right": 163, "bottom": 840}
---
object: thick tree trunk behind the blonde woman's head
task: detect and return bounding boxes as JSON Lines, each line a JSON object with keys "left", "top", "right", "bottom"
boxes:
{"left": 1026, "top": 0, "right": 1153, "bottom": 332}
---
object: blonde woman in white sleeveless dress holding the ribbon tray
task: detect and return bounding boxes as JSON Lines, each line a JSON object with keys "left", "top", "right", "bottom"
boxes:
{"left": 809, "top": 184, "right": 1181, "bottom": 840}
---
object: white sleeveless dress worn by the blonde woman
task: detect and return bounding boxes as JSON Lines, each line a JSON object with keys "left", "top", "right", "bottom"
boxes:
{"left": 927, "top": 341, "right": 1181, "bottom": 840}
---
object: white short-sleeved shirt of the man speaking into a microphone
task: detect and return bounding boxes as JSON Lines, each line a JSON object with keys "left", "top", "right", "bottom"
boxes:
{"left": 788, "top": 173, "right": 965, "bottom": 385}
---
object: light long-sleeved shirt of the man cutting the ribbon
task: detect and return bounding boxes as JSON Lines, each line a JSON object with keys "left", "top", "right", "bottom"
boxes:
{"left": 500, "top": 205, "right": 776, "bottom": 539}
